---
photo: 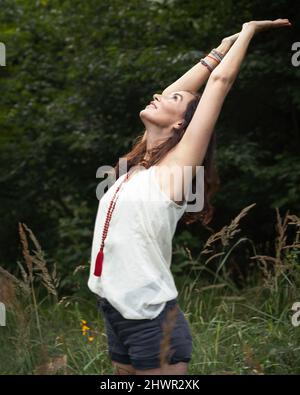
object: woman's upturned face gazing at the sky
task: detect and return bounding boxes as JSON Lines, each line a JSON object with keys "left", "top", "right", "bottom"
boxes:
{"left": 140, "top": 91, "right": 195, "bottom": 128}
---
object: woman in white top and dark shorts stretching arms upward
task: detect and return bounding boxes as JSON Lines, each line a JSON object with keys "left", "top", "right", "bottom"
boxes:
{"left": 88, "top": 19, "right": 291, "bottom": 375}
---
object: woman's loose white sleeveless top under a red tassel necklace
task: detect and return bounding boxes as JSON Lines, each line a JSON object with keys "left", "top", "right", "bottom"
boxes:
{"left": 88, "top": 165, "right": 187, "bottom": 319}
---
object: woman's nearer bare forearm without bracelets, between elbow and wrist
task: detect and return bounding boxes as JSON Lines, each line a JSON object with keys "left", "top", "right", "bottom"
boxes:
{"left": 211, "top": 27, "right": 255, "bottom": 83}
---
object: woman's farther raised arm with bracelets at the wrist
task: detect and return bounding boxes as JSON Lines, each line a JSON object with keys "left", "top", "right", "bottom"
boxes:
{"left": 163, "top": 37, "right": 238, "bottom": 94}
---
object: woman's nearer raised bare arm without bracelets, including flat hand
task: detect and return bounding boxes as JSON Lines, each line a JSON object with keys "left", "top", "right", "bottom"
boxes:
{"left": 169, "top": 19, "right": 290, "bottom": 175}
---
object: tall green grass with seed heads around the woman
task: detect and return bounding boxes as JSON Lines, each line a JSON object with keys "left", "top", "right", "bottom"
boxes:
{"left": 0, "top": 209, "right": 300, "bottom": 375}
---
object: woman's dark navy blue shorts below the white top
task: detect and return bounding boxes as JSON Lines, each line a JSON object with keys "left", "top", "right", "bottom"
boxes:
{"left": 97, "top": 297, "right": 192, "bottom": 370}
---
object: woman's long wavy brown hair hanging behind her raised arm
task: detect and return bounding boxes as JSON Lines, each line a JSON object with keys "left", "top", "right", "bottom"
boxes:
{"left": 114, "top": 91, "right": 220, "bottom": 225}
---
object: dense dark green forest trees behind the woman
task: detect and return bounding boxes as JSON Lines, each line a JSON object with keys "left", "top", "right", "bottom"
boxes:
{"left": 0, "top": 0, "right": 300, "bottom": 293}
